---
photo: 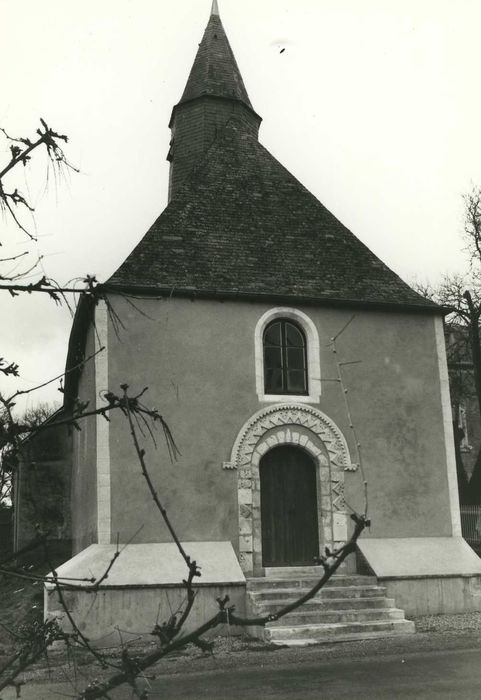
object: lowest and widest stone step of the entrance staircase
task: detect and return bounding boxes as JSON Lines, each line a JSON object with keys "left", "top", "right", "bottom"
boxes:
{"left": 264, "top": 619, "right": 414, "bottom": 646}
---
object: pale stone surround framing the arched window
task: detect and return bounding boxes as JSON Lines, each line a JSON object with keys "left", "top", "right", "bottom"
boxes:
{"left": 254, "top": 306, "right": 321, "bottom": 403}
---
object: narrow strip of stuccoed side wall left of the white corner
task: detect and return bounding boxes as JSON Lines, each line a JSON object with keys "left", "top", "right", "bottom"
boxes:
{"left": 71, "top": 327, "right": 97, "bottom": 554}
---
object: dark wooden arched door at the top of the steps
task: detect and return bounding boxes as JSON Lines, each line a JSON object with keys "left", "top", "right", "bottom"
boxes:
{"left": 259, "top": 445, "right": 319, "bottom": 566}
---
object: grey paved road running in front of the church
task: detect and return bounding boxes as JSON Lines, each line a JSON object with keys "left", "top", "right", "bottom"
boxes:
{"left": 2, "top": 650, "right": 481, "bottom": 700}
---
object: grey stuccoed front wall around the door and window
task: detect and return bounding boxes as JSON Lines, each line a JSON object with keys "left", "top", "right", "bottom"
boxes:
{"left": 99, "top": 296, "right": 452, "bottom": 548}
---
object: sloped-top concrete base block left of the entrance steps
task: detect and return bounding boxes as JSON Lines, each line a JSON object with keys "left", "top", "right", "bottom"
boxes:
{"left": 44, "top": 542, "right": 246, "bottom": 646}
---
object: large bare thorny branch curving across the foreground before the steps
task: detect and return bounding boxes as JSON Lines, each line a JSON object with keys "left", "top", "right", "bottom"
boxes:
{"left": 0, "top": 292, "right": 369, "bottom": 700}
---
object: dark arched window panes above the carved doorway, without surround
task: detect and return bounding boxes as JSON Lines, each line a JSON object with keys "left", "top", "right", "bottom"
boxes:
{"left": 263, "top": 318, "right": 308, "bottom": 395}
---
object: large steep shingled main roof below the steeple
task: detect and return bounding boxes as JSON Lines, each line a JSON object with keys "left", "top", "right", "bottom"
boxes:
{"left": 106, "top": 120, "right": 437, "bottom": 308}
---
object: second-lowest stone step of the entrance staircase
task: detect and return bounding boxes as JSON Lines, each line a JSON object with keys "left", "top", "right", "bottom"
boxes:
{"left": 262, "top": 606, "right": 404, "bottom": 628}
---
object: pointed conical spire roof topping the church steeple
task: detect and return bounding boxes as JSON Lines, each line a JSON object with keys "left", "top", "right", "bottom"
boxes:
{"left": 174, "top": 3, "right": 252, "bottom": 109}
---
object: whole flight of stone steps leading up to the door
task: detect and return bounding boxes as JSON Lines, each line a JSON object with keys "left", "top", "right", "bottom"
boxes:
{"left": 247, "top": 567, "right": 415, "bottom": 646}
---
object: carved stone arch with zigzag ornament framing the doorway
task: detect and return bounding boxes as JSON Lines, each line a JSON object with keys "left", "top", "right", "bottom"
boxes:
{"left": 229, "top": 403, "right": 356, "bottom": 574}
